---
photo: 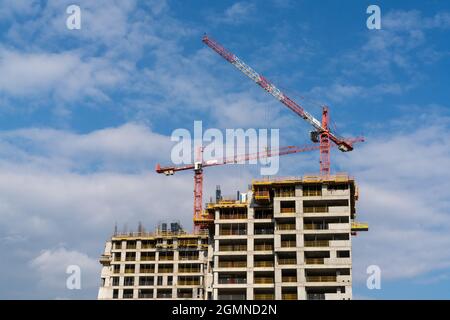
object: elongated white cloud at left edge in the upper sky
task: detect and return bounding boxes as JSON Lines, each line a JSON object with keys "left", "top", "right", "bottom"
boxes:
{"left": 0, "top": 48, "right": 126, "bottom": 102}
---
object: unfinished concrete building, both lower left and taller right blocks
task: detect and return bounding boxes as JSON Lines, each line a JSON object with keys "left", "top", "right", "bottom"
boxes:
{"left": 99, "top": 175, "right": 365, "bottom": 300}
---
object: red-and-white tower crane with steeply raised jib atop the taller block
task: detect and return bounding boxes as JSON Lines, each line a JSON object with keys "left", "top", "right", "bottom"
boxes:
{"left": 202, "top": 35, "right": 364, "bottom": 176}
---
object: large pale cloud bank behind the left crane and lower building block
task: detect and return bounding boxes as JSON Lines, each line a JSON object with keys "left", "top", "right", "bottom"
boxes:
{"left": 0, "top": 124, "right": 262, "bottom": 299}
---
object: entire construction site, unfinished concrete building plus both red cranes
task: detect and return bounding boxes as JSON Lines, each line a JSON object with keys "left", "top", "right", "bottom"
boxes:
{"left": 98, "top": 35, "right": 369, "bottom": 300}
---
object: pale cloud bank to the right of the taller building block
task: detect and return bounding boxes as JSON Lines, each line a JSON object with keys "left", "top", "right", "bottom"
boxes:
{"left": 338, "top": 112, "right": 450, "bottom": 281}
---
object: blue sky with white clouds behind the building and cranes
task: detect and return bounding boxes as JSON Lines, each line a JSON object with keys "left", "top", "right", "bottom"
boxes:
{"left": 0, "top": 0, "right": 450, "bottom": 299}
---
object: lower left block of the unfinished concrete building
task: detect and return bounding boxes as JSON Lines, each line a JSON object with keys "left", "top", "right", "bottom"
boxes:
{"left": 98, "top": 230, "right": 212, "bottom": 300}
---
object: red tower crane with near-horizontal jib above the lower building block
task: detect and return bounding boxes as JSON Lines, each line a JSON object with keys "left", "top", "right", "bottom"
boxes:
{"left": 155, "top": 138, "right": 362, "bottom": 229}
